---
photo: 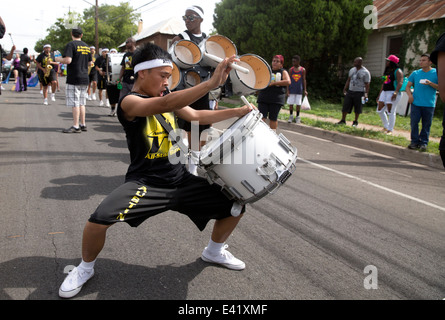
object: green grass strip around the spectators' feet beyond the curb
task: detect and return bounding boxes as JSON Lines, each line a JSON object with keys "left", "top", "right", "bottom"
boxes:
{"left": 220, "top": 96, "right": 443, "bottom": 154}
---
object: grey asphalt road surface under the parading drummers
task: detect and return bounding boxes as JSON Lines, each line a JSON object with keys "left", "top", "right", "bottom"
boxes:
{"left": 0, "top": 79, "right": 445, "bottom": 300}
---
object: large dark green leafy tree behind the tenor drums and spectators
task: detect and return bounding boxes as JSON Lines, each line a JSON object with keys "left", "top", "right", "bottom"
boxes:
{"left": 213, "top": 0, "right": 372, "bottom": 100}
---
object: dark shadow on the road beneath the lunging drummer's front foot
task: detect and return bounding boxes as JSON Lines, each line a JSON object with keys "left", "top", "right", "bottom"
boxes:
{"left": 0, "top": 256, "right": 209, "bottom": 300}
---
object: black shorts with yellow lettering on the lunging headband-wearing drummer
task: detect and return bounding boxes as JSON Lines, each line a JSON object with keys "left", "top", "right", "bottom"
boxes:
{"left": 88, "top": 172, "right": 245, "bottom": 231}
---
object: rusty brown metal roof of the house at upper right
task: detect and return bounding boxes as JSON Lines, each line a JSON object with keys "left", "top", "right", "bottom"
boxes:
{"left": 374, "top": 0, "right": 445, "bottom": 29}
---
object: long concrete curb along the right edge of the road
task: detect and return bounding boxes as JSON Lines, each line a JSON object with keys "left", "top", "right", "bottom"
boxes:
{"left": 278, "top": 120, "right": 444, "bottom": 170}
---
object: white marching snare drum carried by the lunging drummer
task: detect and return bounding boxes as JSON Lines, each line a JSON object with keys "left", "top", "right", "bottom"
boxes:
{"left": 199, "top": 110, "right": 297, "bottom": 205}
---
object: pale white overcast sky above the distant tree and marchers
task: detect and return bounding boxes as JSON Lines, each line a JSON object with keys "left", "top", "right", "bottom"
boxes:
{"left": 0, "top": 0, "right": 220, "bottom": 54}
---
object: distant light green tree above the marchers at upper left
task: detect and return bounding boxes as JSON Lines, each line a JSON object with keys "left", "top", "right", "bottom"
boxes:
{"left": 34, "top": 3, "right": 140, "bottom": 52}
